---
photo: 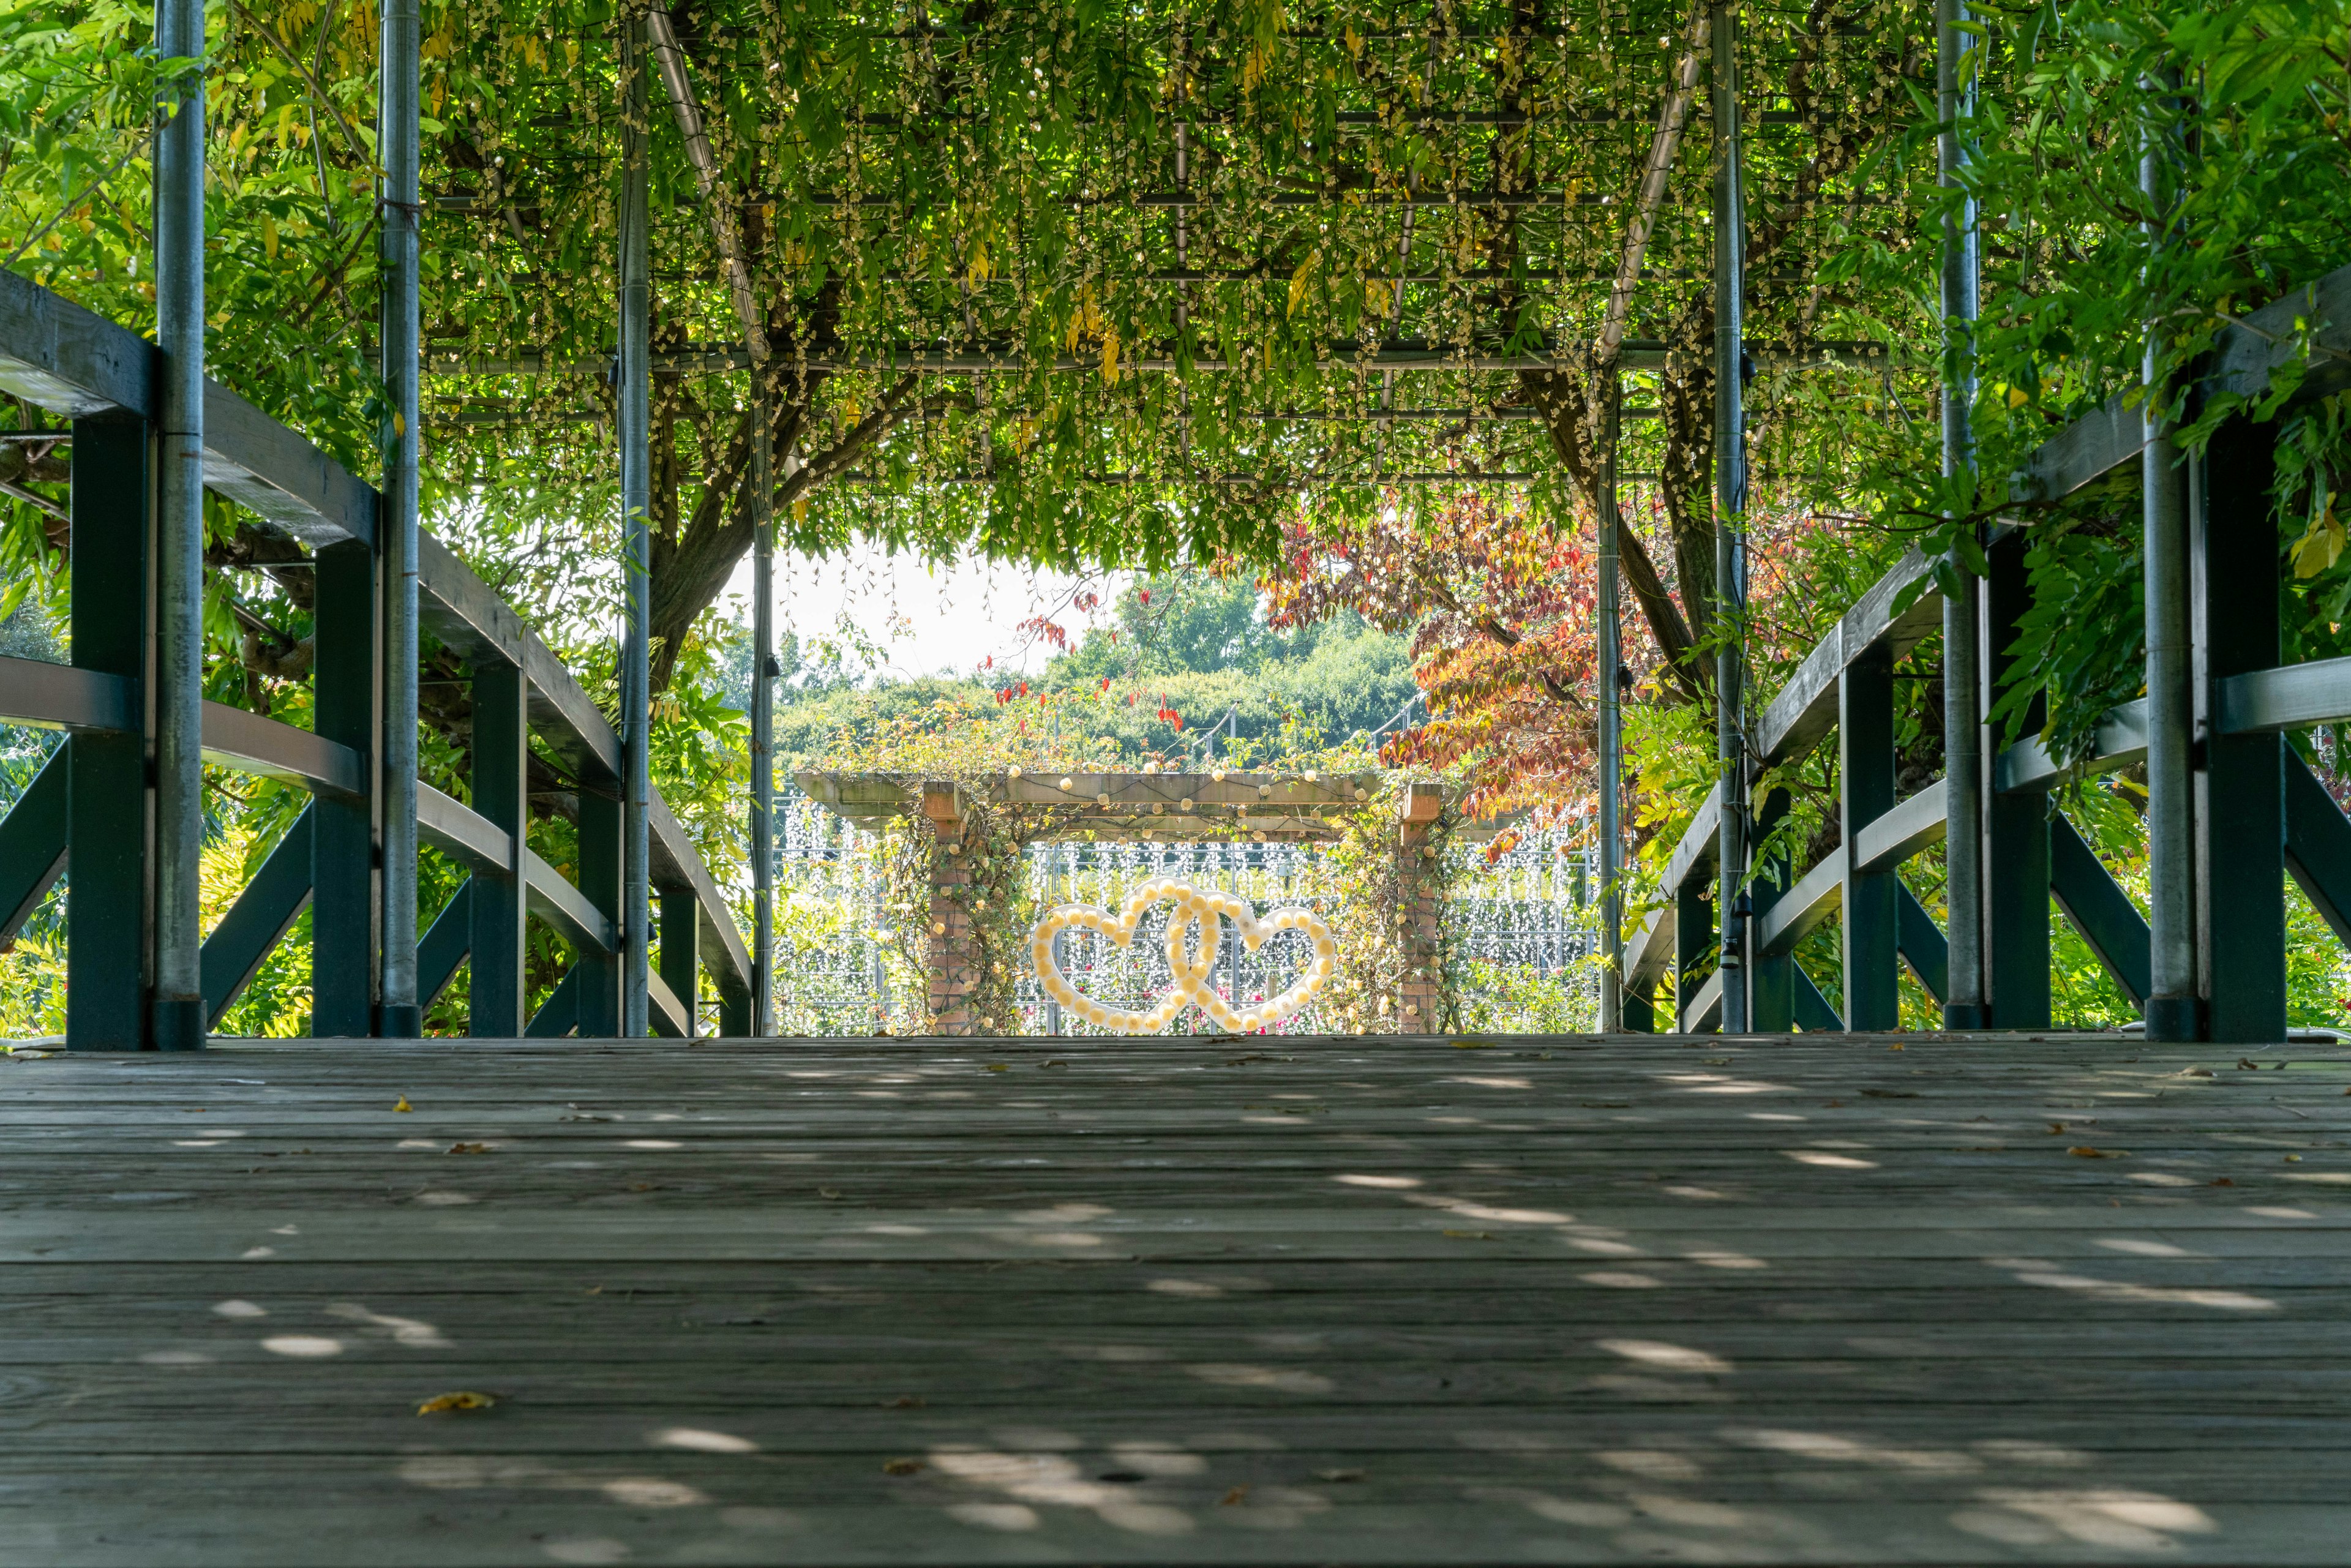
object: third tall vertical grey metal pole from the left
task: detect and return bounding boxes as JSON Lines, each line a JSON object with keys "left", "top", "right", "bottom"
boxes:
{"left": 618, "top": 17, "right": 654, "bottom": 1039}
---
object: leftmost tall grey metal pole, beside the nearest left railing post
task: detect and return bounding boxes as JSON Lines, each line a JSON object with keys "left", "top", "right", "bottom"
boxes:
{"left": 154, "top": 0, "right": 204, "bottom": 1051}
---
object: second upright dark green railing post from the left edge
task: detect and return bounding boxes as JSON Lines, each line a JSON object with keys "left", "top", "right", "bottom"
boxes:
{"left": 310, "top": 541, "right": 386, "bottom": 1037}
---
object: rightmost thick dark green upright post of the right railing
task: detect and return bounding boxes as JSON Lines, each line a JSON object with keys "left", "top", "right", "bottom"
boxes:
{"left": 2181, "top": 418, "right": 2285, "bottom": 1044}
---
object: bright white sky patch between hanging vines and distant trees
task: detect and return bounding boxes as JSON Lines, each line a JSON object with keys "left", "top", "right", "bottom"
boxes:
{"left": 727, "top": 541, "right": 1124, "bottom": 677}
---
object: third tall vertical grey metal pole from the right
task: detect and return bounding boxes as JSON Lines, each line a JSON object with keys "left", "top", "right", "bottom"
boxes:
{"left": 1712, "top": 0, "right": 1747, "bottom": 1034}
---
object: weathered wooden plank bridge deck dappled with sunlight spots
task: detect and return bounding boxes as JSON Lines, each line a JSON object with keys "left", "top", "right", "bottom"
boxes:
{"left": 0, "top": 1037, "right": 2351, "bottom": 1568}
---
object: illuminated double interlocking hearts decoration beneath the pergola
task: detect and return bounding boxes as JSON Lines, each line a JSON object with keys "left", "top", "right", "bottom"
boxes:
{"left": 1030, "top": 877, "right": 1338, "bottom": 1034}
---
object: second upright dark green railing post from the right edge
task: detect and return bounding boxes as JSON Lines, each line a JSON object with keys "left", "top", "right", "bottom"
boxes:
{"left": 1977, "top": 536, "right": 2050, "bottom": 1030}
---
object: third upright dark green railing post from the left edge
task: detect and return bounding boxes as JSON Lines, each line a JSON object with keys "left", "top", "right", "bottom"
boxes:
{"left": 465, "top": 661, "right": 531, "bottom": 1039}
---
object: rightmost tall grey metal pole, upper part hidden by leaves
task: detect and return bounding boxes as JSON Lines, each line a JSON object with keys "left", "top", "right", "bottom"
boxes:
{"left": 2139, "top": 83, "right": 2198, "bottom": 1039}
